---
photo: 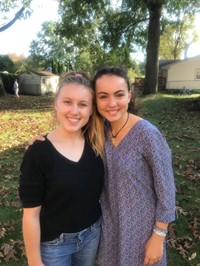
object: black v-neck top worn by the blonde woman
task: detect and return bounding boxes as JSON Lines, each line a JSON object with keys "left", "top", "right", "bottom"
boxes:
{"left": 19, "top": 139, "right": 104, "bottom": 241}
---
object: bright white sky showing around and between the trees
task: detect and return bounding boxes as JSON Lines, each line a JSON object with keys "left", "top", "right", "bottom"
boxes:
{"left": 0, "top": 0, "right": 200, "bottom": 61}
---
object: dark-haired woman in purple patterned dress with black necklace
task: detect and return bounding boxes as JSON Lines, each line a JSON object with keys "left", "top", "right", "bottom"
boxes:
{"left": 93, "top": 68, "right": 175, "bottom": 266}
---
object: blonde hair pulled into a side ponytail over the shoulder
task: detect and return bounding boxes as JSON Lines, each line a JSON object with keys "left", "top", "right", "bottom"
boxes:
{"left": 55, "top": 71, "right": 105, "bottom": 157}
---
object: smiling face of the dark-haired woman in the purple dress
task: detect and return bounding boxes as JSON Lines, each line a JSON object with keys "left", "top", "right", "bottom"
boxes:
{"left": 95, "top": 75, "right": 131, "bottom": 123}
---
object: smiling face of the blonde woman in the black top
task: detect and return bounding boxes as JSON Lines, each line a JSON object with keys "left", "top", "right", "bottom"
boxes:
{"left": 54, "top": 83, "right": 93, "bottom": 133}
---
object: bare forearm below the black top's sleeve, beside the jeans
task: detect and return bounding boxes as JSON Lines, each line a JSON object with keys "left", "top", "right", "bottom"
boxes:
{"left": 22, "top": 206, "right": 44, "bottom": 266}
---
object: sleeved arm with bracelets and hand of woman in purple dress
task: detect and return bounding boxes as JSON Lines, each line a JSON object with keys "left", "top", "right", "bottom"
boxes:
{"left": 144, "top": 128, "right": 175, "bottom": 265}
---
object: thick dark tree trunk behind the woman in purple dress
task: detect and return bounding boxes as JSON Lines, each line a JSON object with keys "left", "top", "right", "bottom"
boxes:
{"left": 143, "top": 0, "right": 162, "bottom": 95}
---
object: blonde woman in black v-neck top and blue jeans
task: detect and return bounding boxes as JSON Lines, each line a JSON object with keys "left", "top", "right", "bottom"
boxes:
{"left": 19, "top": 73, "right": 104, "bottom": 266}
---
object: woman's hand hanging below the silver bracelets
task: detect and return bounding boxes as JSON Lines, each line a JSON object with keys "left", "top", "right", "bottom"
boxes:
{"left": 144, "top": 233, "right": 165, "bottom": 266}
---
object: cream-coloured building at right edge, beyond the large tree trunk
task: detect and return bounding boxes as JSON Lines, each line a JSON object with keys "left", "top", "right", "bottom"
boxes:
{"left": 161, "top": 55, "right": 200, "bottom": 90}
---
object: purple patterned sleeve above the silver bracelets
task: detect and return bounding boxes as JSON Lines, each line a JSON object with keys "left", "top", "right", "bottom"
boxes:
{"left": 146, "top": 128, "right": 176, "bottom": 223}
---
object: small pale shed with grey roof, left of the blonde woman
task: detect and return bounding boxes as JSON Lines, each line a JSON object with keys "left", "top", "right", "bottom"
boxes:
{"left": 19, "top": 71, "right": 59, "bottom": 95}
